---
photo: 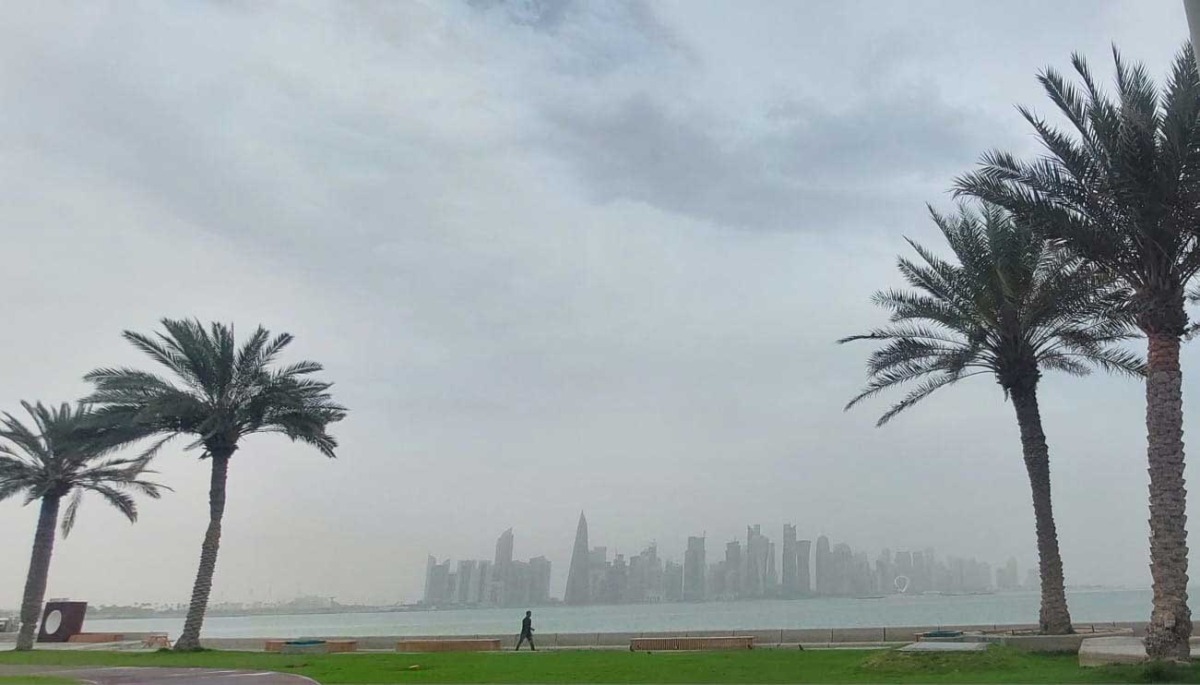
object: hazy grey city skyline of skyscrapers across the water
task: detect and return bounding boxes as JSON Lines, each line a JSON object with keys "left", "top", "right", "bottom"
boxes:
{"left": 420, "top": 511, "right": 1036, "bottom": 607}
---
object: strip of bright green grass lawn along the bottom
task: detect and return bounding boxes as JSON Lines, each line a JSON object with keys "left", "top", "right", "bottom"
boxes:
{"left": 0, "top": 648, "right": 1200, "bottom": 685}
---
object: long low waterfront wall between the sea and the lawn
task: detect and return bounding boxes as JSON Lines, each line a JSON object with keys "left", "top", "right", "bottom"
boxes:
{"left": 200, "top": 623, "right": 1142, "bottom": 651}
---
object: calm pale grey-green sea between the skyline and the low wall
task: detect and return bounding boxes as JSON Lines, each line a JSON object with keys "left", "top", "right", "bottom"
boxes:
{"left": 77, "top": 589, "right": 1151, "bottom": 637}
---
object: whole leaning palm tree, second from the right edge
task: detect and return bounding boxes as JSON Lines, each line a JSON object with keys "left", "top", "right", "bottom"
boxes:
{"left": 839, "top": 205, "right": 1142, "bottom": 635}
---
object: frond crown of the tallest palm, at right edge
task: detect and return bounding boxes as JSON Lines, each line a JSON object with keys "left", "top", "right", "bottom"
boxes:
{"left": 956, "top": 46, "right": 1200, "bottom": 335}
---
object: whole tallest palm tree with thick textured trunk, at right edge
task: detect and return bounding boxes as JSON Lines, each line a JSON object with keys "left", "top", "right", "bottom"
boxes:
{"left": 956, "top": 47, "right": 1200, "bottom": 660}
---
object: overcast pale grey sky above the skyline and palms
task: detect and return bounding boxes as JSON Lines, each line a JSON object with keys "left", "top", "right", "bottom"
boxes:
{"left": 0, "top": 0, "right": 1200, "bottom": 611}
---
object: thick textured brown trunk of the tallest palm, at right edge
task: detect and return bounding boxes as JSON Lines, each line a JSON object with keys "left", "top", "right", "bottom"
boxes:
{"left": 1146, "top": 332, "right": 1192, "bottom": 661}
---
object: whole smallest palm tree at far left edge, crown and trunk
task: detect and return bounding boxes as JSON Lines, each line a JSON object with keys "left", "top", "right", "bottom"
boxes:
{"left": 0, "top": 402, "right": 167, "bottom": 650}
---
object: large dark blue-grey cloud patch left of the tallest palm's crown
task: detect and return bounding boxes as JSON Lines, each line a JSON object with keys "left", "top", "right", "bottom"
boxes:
{"left": 547, "top": 84, "right": 986, "bottom": 232}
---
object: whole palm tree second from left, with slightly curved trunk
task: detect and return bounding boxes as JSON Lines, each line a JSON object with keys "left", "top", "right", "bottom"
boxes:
{"left": 85, "top": 319, "right": 346, "bottom": 650}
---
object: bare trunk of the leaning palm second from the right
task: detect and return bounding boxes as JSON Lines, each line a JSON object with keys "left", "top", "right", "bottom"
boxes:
{"left": 1012, "top": 385, "right": 1074, "bottom": 635}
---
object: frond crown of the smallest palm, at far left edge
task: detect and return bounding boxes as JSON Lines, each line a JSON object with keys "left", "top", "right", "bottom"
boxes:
{"left": 0, "top": 402, "right": 169, "bottom": 535}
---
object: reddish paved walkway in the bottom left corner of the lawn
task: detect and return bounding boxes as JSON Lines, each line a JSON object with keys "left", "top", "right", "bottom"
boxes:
{"left": 0, "top": 666, "right": 319, "bottom": 685}
